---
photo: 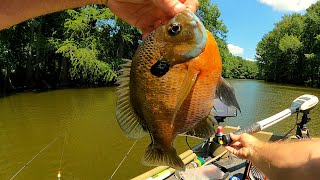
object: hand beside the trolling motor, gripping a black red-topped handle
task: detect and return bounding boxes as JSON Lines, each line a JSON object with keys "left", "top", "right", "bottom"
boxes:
{"left": 225, "top": 133, "right": 263, "bottom": 159}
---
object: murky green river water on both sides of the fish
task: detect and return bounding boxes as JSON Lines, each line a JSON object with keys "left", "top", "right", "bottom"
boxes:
{"left": 0, "top": 79, "right": 320, "bottom": 179}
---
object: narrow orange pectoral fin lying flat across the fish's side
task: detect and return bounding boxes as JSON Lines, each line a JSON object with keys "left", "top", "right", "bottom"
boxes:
{"left": 171, "top": 68, "right": 200, "bottom": 126}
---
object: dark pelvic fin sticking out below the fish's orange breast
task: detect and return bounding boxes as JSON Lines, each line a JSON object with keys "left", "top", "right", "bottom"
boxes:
{"left": 216, "top": 77, "right": 241, "bottom": 112}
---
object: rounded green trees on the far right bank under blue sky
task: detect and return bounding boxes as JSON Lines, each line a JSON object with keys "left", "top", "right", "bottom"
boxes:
{"left": 256, "top": 1, "right": 320, "bottom": 87}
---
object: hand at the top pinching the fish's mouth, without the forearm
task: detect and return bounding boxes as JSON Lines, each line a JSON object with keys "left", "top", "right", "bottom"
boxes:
{"left": 105, "top": 0, "right": 199, "bottom": 37}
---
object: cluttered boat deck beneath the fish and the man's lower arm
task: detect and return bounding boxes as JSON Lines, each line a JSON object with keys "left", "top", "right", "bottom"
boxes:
{"left": 134, "top": 126, "right": 288, "bottom": 180}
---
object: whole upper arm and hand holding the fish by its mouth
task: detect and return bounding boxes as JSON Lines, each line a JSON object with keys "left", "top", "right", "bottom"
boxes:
{"left": 0, "top": 0, "right": 199, "bottom": 37}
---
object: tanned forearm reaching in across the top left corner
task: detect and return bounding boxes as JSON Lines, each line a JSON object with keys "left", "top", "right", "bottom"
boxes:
{"left": 0, "top": 0, "right": 106, "bottom": 30}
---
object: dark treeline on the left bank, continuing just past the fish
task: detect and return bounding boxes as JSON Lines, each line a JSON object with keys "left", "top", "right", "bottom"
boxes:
{"left": 0, "top": 0, "right": 258, "bottom": 95}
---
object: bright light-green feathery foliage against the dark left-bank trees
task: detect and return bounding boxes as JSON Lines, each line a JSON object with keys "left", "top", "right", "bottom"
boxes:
{"left": 50, "top": 6, "right": 116, "bottom": 85}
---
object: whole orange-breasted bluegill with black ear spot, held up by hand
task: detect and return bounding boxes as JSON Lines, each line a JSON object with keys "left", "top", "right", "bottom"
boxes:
{"left": 116, "top": 10, "right": 239, "bottom": 169}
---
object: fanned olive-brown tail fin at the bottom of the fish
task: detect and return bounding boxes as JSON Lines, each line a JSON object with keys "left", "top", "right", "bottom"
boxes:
{"left": 142, "top": 143, "right": 186, "bottom": 170}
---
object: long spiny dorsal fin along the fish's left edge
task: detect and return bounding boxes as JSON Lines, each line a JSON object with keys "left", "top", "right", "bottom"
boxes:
{"left": 116, "top": 60, "right": 145, "bottom": 139}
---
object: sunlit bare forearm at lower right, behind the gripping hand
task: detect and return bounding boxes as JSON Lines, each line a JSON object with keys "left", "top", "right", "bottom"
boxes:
{"left": 249, "top": 140, "right": 320, "bottom": 179}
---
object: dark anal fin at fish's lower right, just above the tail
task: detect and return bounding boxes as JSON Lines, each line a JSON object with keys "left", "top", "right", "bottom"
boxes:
{"left": 181, "top": 117, "right": 215, "bottom": 139}
